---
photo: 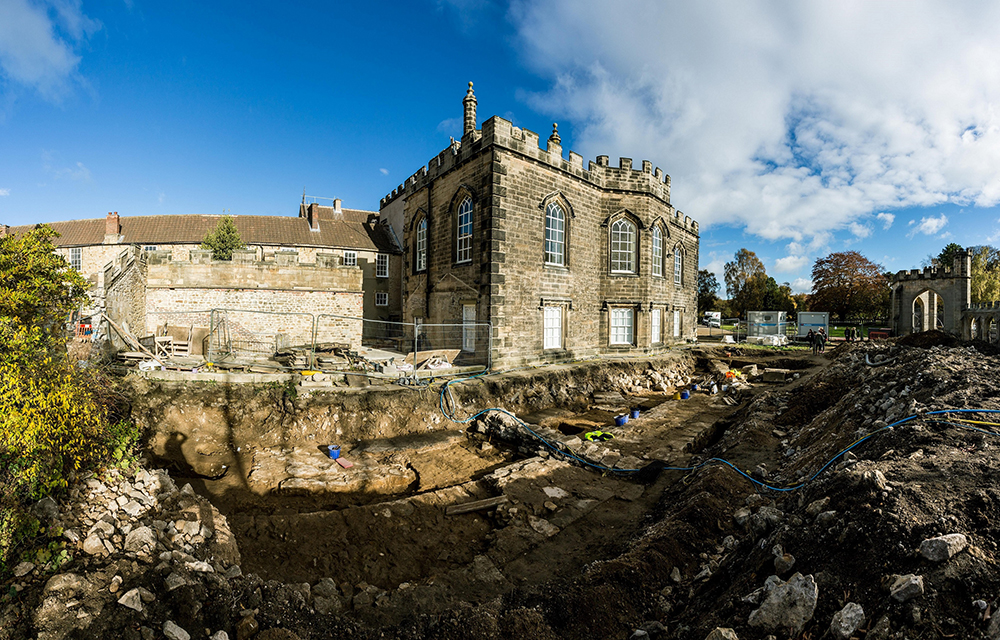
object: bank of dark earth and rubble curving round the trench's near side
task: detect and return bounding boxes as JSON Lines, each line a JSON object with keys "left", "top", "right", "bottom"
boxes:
{"left": 0, "top": 334, "right": 1000, "bottom": 640}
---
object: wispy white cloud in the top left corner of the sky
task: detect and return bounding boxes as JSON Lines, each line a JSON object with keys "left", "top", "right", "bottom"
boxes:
{"left": 0, "top": 0, "right": 101, "bottom": 101}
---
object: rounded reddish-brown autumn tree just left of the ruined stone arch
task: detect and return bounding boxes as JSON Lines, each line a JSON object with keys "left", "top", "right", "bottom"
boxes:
{"left": 809, "top": 251, "right": 889, "bottom": 321}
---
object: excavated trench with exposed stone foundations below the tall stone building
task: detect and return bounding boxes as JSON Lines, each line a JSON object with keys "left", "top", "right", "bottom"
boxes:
{"left": 123, "top": 352, "right": 764, "bottom": 620}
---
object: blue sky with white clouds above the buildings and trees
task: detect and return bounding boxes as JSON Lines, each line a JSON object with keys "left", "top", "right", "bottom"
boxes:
{"left": 0, "top": 0, "right": 1000, "bottom": 294}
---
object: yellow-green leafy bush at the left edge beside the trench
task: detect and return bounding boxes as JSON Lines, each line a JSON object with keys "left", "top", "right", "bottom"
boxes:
{"left": 0, "top": 226, "right": 135, "bottom": 580}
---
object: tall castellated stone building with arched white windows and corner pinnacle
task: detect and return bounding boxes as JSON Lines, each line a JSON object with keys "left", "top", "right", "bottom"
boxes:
{"left": 379, "top": 83, "right": 698, "bottom": 366}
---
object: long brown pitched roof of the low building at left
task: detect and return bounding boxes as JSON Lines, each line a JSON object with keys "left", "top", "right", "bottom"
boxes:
{"left": 10, "top": 207, "right": 400, "bottom": 253}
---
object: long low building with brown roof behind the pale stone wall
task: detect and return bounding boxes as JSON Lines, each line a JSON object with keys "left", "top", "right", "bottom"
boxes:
{"left": 0, "top": 199, "right": 402, "bottom": 320}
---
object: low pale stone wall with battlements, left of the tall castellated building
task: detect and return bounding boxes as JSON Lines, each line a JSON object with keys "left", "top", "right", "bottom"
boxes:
{"left": 104, "top": 247, "right": 365, "bottom": 355}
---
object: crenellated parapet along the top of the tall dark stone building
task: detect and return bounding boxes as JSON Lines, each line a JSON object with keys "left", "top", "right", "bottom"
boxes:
{"left": 380, "top": 116, "right": 698, "bottom": 234}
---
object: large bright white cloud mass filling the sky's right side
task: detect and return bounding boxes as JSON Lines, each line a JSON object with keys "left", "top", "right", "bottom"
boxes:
{"left": 510, "top": 0, "right": 1000, "bottom": 246}
